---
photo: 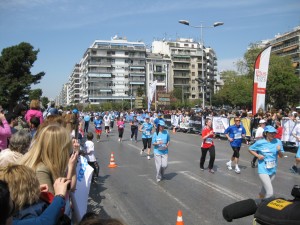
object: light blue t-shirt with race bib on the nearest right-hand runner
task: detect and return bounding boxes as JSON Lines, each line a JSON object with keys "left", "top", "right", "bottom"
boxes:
{"left": 249, "top": 138, "right": 284, "bottom": 175}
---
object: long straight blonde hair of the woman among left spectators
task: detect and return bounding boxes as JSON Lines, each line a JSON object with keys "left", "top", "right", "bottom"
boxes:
{"left": 21, "top": 124, "right": 72, "bottom": 180}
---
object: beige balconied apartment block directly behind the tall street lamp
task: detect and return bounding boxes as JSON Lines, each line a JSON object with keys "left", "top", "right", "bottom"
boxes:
{"left": 152, "top": 38, "right": 217, "bottom": 104}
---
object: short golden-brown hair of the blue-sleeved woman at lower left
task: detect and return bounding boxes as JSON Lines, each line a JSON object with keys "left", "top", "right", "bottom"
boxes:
{"left": 0, "top": 164, "right": 40, "bottom": 211}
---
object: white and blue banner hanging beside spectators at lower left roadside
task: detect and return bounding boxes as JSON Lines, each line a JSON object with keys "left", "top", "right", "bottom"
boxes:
{"left": 71, "top": 156, "right": 94, "bottom": 222}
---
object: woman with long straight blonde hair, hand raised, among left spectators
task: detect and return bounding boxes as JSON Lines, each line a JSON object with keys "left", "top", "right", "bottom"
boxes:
{"left": 21, "top": 124, "right": 79, "bottom": 194}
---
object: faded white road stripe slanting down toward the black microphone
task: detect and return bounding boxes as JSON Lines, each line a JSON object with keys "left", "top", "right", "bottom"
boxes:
{"left": 178, "top": 171, "right": 246, "bottom": 200}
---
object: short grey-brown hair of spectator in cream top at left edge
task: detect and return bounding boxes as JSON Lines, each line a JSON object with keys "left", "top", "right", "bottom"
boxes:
{"left": 8, "top": 130, "right": 31, "bottom": 155}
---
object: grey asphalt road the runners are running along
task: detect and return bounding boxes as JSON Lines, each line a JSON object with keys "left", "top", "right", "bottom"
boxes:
{"left": 88, "top": 125, "right": 300, "bottom": 225}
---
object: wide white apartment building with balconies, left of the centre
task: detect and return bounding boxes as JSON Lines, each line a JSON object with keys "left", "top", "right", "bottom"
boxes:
{"left": 79, "top": 37, "right": 146, "bottom": 104}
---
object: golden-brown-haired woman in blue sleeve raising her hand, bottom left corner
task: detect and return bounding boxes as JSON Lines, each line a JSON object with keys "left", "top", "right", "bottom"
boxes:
{"left": 0, "top": 164, "right": 70, "bottom": 225}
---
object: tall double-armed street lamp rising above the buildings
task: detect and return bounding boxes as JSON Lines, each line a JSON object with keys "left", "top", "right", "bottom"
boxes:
{"left": 178, "top": 20, "right": 224, "bottom": 109}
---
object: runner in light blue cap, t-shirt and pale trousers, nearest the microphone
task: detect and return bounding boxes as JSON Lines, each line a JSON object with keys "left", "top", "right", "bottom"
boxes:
{"left": 249, "top": 125, "right": 284, "bottom": 198}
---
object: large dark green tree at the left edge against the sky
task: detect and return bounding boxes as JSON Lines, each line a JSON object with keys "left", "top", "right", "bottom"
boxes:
{"left": 0, "top": 42, "right": 45, "bottom": 111}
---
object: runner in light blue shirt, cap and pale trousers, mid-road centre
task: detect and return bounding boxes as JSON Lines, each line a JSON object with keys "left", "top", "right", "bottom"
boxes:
{"left": 152, "top": 120, "right": 170, "bottom": 182}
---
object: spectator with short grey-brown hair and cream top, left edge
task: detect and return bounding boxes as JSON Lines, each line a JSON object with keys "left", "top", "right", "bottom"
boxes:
{"left": 0, "top": 130, "right": 31, "bottom": 167}
